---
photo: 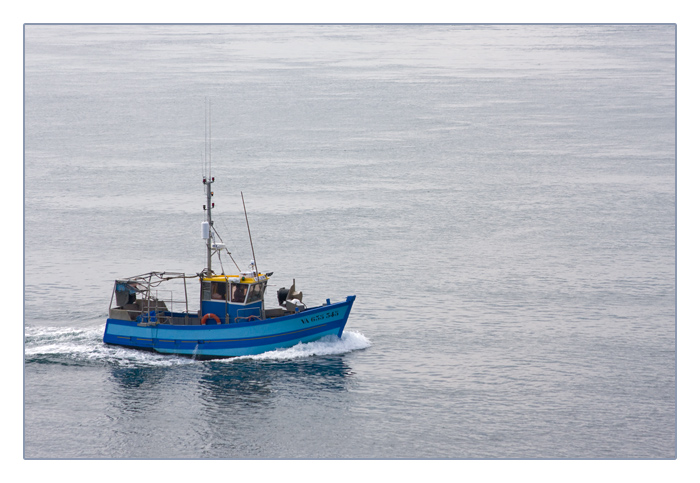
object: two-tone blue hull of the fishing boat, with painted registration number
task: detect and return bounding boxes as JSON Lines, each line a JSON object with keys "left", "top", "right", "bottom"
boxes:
{"left": 103, "top": 295, "right": 355, "bottom": 358}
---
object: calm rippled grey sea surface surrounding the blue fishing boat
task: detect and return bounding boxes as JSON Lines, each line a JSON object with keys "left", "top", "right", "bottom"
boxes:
{"left": 24, "top": 24, "right": 677, "bottom": 459}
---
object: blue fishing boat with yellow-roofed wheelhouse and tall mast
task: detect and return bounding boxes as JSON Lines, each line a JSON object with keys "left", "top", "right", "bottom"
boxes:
{"left": 103, "top": 108, "right": 355, "bottom": 359}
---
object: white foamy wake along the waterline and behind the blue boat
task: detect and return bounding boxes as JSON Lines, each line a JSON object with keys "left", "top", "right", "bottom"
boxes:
{"left": 24, "top": 325, "right": 371, "bottom": 367}
